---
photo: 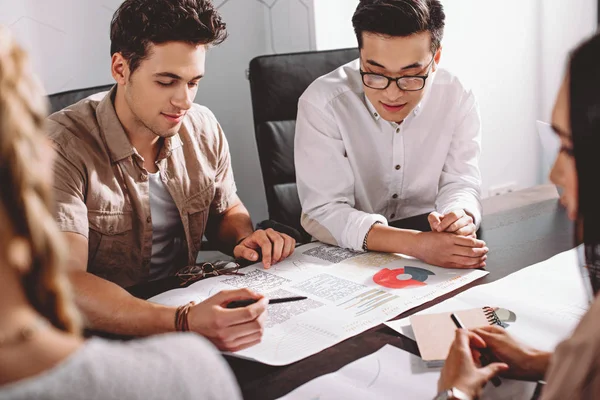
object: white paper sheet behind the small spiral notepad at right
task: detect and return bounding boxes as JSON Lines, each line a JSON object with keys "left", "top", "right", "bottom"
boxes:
{"left": 386, "top": 249, "right": 589, "bottom": 351}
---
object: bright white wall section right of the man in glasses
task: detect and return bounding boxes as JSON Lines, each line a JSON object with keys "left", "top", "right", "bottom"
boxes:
{"left": 441, "top": 0, "right": 541, "bottom": 195}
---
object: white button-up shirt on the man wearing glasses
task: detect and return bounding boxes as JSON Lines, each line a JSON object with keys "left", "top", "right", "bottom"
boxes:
{"left": 294, "top": 60, "right": 481, "bottom": 251}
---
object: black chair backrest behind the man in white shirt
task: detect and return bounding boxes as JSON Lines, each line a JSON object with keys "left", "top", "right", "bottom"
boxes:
{"left": 249, "top": 48, "right": 358, "bottom": 236}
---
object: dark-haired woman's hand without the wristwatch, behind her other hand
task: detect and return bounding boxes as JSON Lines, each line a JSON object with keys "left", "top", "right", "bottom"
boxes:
{"left": 472, "top": 325, "right": 551, "bottom": 381}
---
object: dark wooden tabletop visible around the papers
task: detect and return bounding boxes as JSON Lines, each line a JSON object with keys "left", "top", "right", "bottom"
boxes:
{"left": 130, "top": 186, "right": 573, "bottom": 400}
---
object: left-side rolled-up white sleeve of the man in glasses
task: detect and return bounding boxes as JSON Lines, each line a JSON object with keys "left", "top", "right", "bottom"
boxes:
{"left": 294, "top": 99, "right": 387, "bottom": 251}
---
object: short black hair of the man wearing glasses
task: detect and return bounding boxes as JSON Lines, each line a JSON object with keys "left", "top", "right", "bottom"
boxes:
{"left": 352, "top": 0, "right": 446, "bottom": 51}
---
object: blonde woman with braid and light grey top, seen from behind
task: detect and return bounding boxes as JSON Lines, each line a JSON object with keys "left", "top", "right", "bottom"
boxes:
{"left": 0, "top": 28, "right": 240, "bottom": 400}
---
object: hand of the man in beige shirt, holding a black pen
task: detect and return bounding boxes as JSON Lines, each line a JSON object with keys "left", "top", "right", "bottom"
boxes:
{"left": 188, "top": 289, "right": 268, "bottom": 351}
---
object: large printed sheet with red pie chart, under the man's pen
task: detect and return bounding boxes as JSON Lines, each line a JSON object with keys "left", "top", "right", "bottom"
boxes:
{"left": 150, "top": 242, "right": 487, "bottom": 365}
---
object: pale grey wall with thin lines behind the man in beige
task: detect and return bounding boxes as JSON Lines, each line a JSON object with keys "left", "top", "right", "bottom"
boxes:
{"left": 0, "top": 0, "right": 315, "bottom": 222}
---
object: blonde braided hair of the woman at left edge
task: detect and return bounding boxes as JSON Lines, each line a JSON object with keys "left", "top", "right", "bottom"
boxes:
{"left": 0, "top": 27, "right": 80, "bottom": 333}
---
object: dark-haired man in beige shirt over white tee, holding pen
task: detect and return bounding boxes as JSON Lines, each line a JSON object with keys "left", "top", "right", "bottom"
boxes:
{"left": 48, "top": 0, "right": 295, "bottom": 351}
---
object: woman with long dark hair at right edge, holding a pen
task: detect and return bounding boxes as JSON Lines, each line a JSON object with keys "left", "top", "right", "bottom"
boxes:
{"left": 438, "top": 35, "right": 600, "bottom": 400}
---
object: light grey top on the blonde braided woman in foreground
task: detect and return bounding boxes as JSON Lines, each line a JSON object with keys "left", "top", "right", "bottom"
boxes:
{"left": 0, "top": 333, "right": 242, "bottom": 400}
